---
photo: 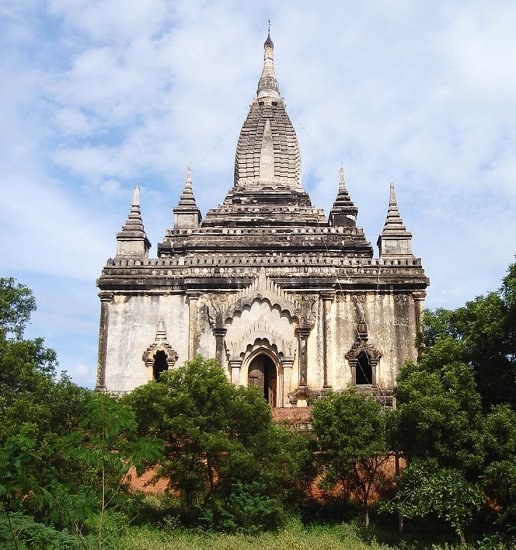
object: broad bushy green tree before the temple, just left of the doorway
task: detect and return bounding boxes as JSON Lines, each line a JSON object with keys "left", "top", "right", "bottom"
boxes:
{"left": 125, "top": 356, "right": 304, "bottom": 527}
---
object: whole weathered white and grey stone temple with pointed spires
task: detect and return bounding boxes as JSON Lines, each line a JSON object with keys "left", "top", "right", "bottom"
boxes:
{"left": 97, "top": 33, "right": 429, "bottom": 407}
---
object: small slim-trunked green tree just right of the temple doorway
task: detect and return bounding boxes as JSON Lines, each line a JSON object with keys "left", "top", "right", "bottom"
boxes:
{"left": 312, "top": 389, "right": 389, "bottom": 527}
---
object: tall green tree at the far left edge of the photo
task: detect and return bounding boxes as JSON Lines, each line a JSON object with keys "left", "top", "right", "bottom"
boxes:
{"left": 0, "top": 279, "right": 84, "bottom": 544}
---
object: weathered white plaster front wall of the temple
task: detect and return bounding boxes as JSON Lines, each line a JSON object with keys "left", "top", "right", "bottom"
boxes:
{"left": 100, "top": 292, "right": 417, "bottom": 403}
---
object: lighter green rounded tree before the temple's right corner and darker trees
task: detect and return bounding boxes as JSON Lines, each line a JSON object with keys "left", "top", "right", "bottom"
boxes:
{"left": 395, "top": 350, "right": 483, "bottom": 475}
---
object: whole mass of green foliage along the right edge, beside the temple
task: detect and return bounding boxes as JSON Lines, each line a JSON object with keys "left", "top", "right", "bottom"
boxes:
{"left": 394, "top": 264, "right": 516, "bottom": 537}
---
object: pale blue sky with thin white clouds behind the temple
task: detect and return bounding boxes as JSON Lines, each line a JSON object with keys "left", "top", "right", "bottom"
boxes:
{"left": 0, "top": 0, "right": 516, "bottom": 387}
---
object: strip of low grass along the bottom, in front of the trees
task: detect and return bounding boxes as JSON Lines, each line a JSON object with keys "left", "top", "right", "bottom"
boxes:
{"left": 106, "top": 495, "right": 516, "bottom": 550}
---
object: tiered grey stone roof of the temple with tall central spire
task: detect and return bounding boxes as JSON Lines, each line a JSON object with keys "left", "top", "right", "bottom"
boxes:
{"left": 99, "top": 33, "right": 428, "bottom": 296}
